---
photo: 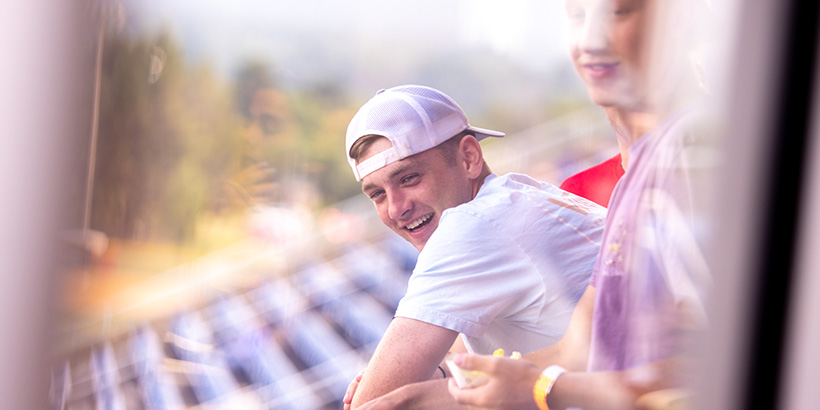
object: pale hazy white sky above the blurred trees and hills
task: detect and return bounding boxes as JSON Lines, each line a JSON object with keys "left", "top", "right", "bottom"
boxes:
{"left": 127, "top": 0, "right": 567, "bottom": 82}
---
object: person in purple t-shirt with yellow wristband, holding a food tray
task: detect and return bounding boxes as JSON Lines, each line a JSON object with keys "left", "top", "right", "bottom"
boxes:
{"left": 449, "top": 0, "right": 710, "bottom": 409}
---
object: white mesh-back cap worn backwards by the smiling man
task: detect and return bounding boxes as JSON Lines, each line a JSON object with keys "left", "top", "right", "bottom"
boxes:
{"left": 345, "top": 85, "right": 504, "bottom": 181}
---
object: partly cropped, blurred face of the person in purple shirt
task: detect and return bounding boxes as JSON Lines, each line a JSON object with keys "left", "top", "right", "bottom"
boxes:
{"left": 565, "top": 0, "right": 652, "bottom": 108}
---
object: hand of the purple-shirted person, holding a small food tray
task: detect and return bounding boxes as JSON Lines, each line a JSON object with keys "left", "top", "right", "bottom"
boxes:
{"left": 447, "top": 354, "right": 541, "bottom": 410}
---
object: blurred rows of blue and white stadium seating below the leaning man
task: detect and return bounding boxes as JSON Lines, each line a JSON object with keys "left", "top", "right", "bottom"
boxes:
{"left": 51, "top": 235, "right": 413, "bottom": 410}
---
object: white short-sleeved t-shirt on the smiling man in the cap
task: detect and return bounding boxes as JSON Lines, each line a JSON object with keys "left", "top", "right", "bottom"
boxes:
{"left": 396, "top": 174, "right": 606, "bottom": 354}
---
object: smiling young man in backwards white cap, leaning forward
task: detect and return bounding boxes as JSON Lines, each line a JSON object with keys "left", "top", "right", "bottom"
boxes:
{"left": 345, "top": 85, "right": 605, "bottom": 408}
